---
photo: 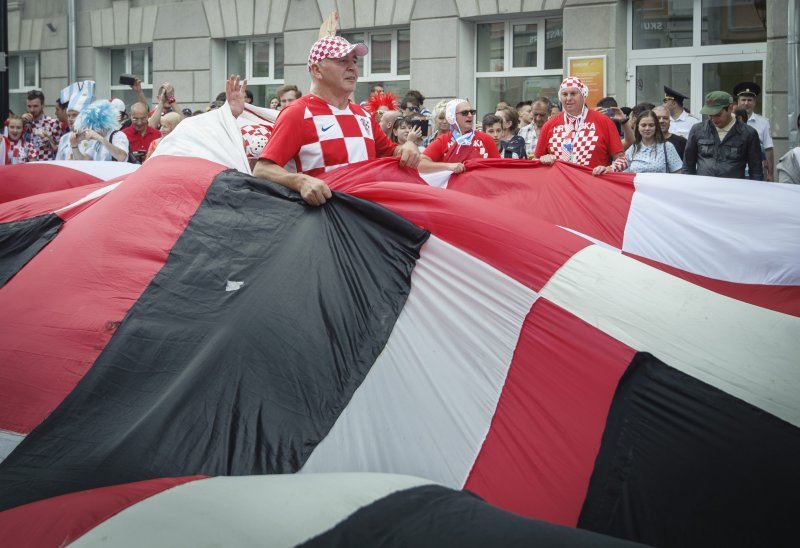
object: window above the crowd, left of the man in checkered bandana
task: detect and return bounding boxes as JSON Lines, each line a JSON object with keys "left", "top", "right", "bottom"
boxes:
{"left": 475, "top": 18, "right": 563, "bottom": 116}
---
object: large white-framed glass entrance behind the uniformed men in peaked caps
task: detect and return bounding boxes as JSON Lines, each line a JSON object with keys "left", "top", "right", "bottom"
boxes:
{"left": 628, "top": 0, "right": 769, "bottom": 115}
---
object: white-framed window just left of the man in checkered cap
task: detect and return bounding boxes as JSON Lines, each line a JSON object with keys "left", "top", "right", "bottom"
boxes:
{"left": 225, "top": 36, "right": 283, "bottom": 107}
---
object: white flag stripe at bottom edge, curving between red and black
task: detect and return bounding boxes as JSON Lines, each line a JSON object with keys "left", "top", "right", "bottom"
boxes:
{"left": 70, "top": 474, "right": 431, "bottom": 548}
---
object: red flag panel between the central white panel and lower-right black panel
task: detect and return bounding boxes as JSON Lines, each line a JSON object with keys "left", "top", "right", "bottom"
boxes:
{"left": 464, "top": 298, "right": 635, "bottom": 526}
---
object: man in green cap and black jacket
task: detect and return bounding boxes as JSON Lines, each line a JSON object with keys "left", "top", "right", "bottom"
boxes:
{"left": 683, "top": 91, "right": 764, "bottom": 181}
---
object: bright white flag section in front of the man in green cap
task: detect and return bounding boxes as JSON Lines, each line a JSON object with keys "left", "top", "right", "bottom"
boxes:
{"left": 622, "top": 173, "right": 800, "bottom": 285}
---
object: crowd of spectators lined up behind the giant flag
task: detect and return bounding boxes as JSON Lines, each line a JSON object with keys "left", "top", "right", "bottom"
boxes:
{"left": 0, "top": 69, "right": 800, "bottom": 183}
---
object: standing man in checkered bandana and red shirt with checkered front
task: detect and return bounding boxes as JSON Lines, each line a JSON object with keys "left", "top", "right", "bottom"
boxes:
{"left": 534, "top": 77, "right": 627, "bottom": 175}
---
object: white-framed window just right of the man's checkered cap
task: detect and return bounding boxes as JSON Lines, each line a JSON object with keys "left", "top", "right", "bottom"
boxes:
{"left": 342, "top": 28, "right": 411, "bottom": 102}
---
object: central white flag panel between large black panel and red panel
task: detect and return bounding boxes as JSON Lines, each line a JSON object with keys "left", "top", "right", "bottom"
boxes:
{"left": 301, "top": 236, "right": 537, "bottom": 489}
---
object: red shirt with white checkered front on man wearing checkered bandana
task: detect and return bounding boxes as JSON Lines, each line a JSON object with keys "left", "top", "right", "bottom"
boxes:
{"left": 534, "top": 110, "right": 623, "bottom": 167}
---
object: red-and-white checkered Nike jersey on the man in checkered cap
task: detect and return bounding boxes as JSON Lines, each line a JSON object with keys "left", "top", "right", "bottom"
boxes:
{"left": 260, "top": 95, "right": 397, "bottom": 176}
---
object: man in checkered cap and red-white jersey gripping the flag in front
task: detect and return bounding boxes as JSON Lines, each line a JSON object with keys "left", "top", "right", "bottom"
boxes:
{"left": 253, "top": 36, "right": 420, "bottom": 205}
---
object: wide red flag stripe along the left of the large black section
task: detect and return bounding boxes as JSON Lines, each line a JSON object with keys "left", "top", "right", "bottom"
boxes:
{"left": 0, "top": 157, "right": 223, "bottom": 434}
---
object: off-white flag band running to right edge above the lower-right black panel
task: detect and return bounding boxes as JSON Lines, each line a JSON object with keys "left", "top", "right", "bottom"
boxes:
{"left": 541, "top": 246, "right": 800, "bottom": 426}
